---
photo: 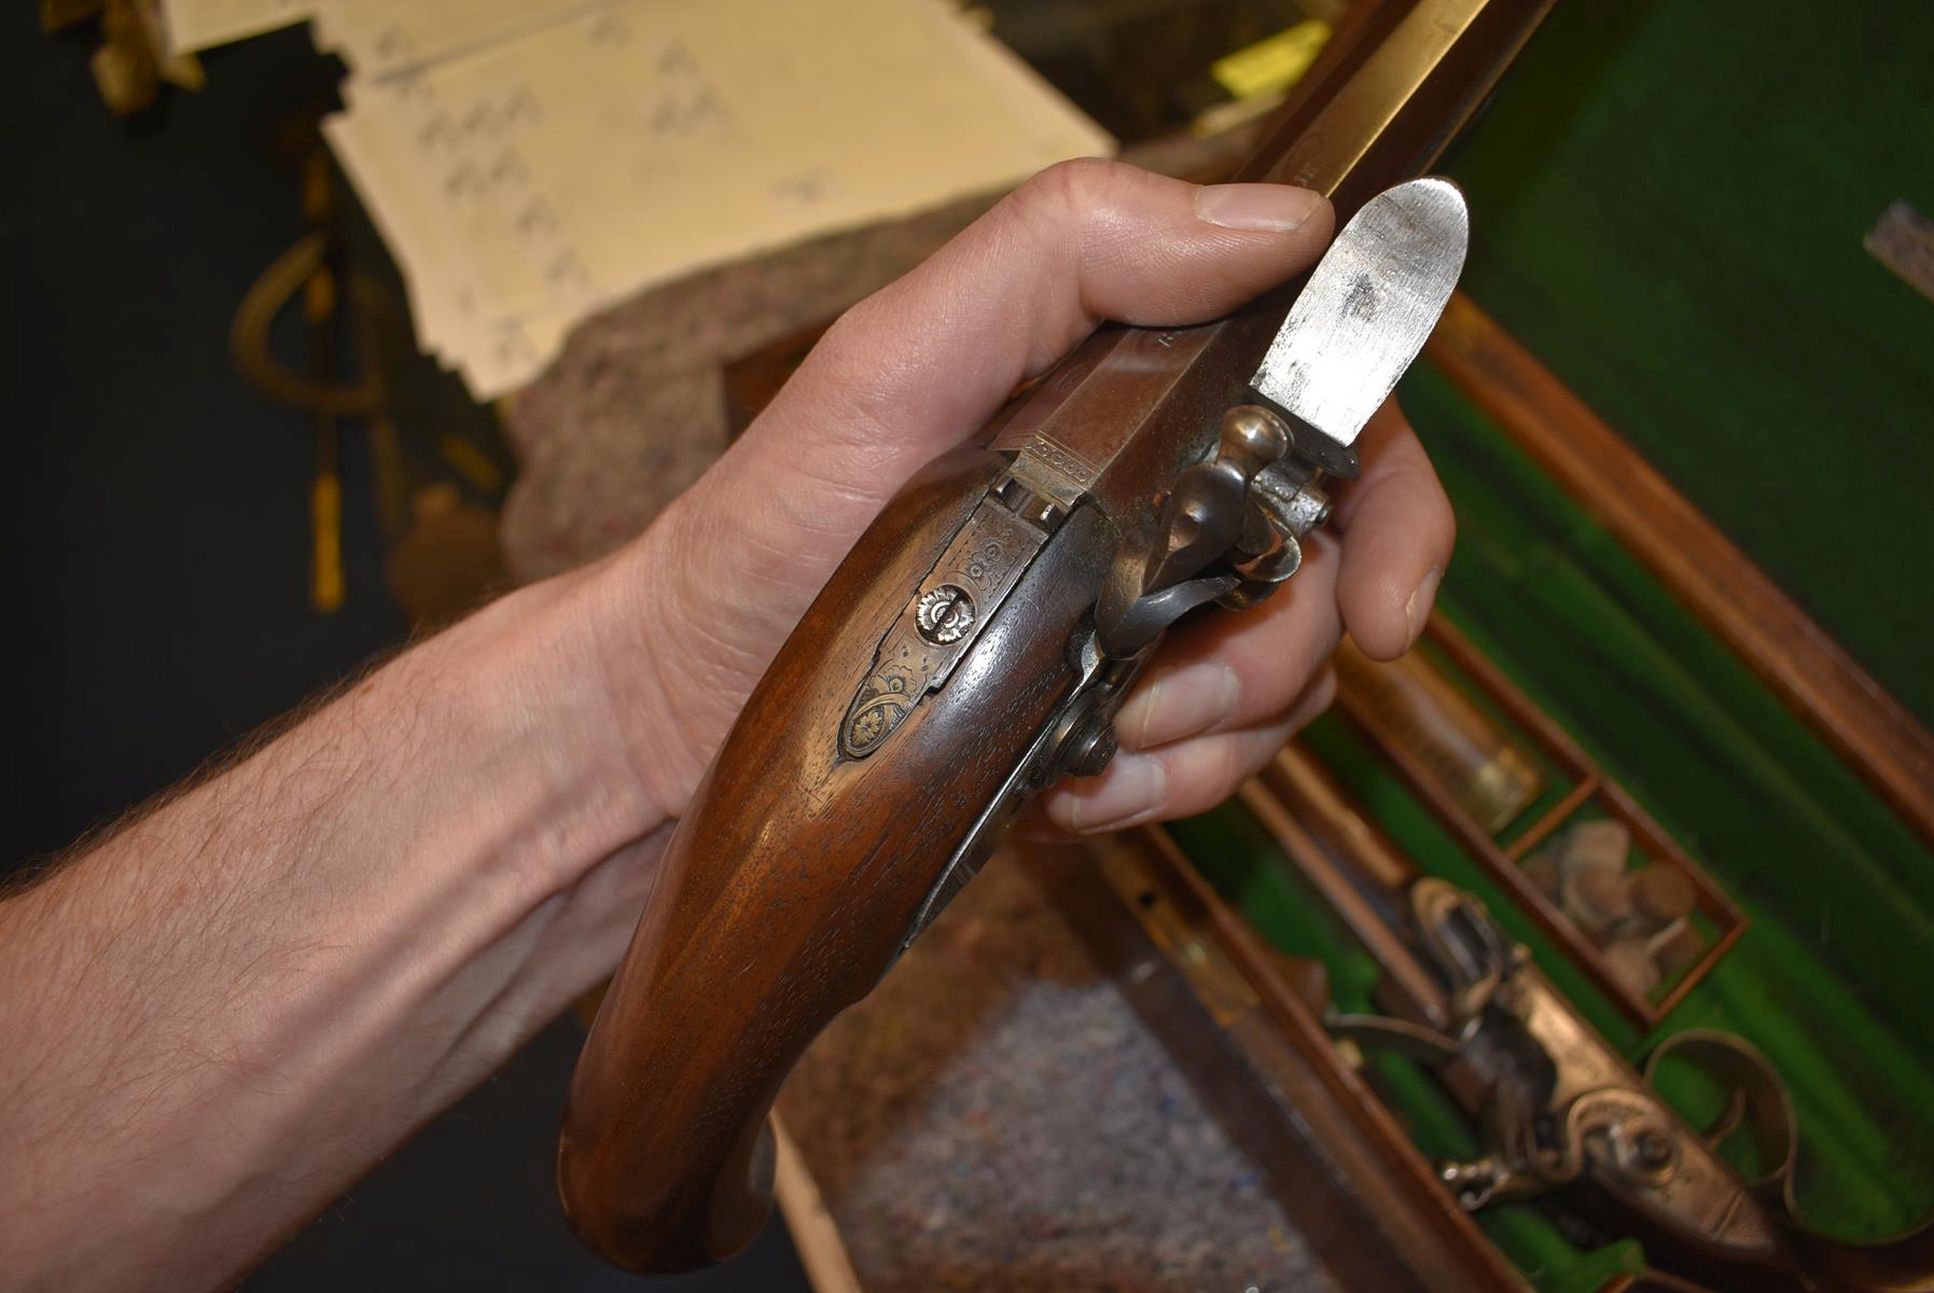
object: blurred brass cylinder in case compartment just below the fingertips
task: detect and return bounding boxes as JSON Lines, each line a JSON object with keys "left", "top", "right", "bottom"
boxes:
{"left": 1334, "top": 642, "right": 1545, "bottom": 835}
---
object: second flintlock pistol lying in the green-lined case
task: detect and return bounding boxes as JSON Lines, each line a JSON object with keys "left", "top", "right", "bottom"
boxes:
{"left": 1240, "top": 744, "right": 1934, "bottom": 1293}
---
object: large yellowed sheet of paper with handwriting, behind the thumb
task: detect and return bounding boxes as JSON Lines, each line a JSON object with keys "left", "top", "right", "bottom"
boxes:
{"left": 323, "top": 0, "right": 1112, "bottom": 398}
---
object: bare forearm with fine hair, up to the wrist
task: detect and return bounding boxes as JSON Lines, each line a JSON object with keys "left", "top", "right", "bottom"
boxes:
{"left": 0, "top": 564, "right": 663, "bottom": 1289}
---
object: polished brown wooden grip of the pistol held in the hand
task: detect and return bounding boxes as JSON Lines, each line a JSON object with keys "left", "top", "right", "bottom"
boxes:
{"left": 557, "top": 448, "right": 1114, "bottom": 1272}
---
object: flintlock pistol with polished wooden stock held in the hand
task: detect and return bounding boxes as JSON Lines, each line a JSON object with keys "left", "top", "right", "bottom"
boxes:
{"left": 557, "top": 0, "right": 1549, "bottom": 1270}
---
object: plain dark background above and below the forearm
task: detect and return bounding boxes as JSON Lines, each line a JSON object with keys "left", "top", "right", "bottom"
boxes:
{"left": 0, "top": 4, "right": 805, "bottom": 1291}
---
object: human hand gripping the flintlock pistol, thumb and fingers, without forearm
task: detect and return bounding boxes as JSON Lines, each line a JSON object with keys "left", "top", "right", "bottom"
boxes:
{"left": 603, "top": 160, "right": 1452, "bottom": 833}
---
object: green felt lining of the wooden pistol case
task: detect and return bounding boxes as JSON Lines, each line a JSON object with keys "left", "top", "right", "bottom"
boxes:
{"left": 1180, "top": 0, "right": 1934, "bottom": 1267}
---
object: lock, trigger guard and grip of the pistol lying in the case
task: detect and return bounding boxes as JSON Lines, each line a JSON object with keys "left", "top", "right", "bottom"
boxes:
{"left": 1327, "top": 876, "right": 1934, "bottom": 1293}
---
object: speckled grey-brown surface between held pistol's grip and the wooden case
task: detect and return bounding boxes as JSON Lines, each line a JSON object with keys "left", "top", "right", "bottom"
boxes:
{"left": 779, "top": 854, "right": 1334, "bottom": 1293}
